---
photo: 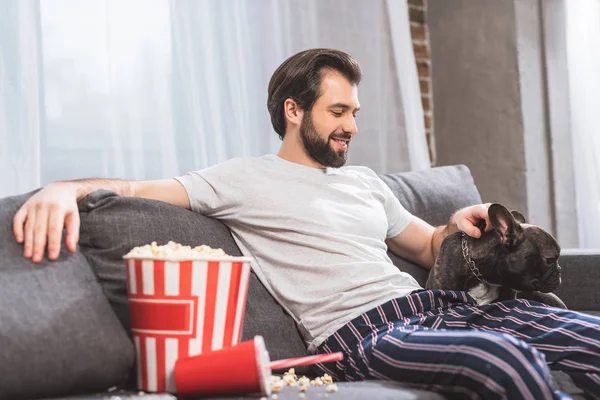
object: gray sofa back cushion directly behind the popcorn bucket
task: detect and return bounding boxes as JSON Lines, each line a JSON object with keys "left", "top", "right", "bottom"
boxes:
{"left": 79, "top": 190, "right": 306, "bottom": 359}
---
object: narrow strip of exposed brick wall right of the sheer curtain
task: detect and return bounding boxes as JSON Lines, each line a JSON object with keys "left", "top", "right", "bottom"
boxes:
{"left": 408, "top": 0, "right": 436, "bottom": 166}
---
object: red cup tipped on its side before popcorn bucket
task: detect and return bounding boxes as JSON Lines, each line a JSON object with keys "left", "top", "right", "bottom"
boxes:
{"left": 174, "top": 336, "right": 271, "bottom": 396}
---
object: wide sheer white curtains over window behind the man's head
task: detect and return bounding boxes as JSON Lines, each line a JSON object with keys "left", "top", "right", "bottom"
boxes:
{"left": 0, "top": 0, "right": 429, "bottom": 197}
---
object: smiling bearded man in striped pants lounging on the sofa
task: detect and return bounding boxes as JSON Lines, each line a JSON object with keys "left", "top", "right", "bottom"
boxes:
{"left": 14, "top": 49, "right": 600, "bottom": 400}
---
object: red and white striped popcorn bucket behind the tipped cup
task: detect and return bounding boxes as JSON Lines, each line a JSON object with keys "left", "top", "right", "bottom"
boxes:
{"left": 124, "top": 256, "right": 252, "bottom": 393}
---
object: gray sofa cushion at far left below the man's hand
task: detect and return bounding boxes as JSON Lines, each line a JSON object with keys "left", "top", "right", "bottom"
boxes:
{"left": 0, "top": 193, "right": 134, "bottom": 399}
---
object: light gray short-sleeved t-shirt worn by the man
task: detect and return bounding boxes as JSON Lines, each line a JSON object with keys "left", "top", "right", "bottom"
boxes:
{"left": 176, "top": 155, "right": 420, "bottom": 352}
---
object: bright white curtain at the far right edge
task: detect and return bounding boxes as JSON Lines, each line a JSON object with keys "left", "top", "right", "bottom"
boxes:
{"left": 556, "top": 0, "right": 600, "bottom": 248}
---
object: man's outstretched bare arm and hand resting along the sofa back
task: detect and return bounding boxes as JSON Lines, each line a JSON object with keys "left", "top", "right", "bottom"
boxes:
{"left": 13, "top": 179, "right": 190, "bottom": 262}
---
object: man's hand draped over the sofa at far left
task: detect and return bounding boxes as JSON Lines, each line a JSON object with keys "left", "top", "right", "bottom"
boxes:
{"left": 13, "top": 182, "right": 79, "bottom": 262}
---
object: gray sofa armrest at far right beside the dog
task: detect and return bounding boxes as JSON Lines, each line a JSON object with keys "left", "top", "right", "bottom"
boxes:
{"left": 556, "top": 249, "right": 600, "bottom": 311}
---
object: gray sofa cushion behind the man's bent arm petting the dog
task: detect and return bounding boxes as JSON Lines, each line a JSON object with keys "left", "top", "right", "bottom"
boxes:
{"left": 380, "top": 165, "right": 481, "bottom": 285}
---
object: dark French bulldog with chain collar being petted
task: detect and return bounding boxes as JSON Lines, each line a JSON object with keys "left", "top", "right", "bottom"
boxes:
{"left": 426, "top": 204, "right": 567, "bottom": 308}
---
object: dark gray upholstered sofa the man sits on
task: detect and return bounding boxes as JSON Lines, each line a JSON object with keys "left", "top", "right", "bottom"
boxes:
{"left": 0, "top": 166, "right": 600, "bottom": 400}
